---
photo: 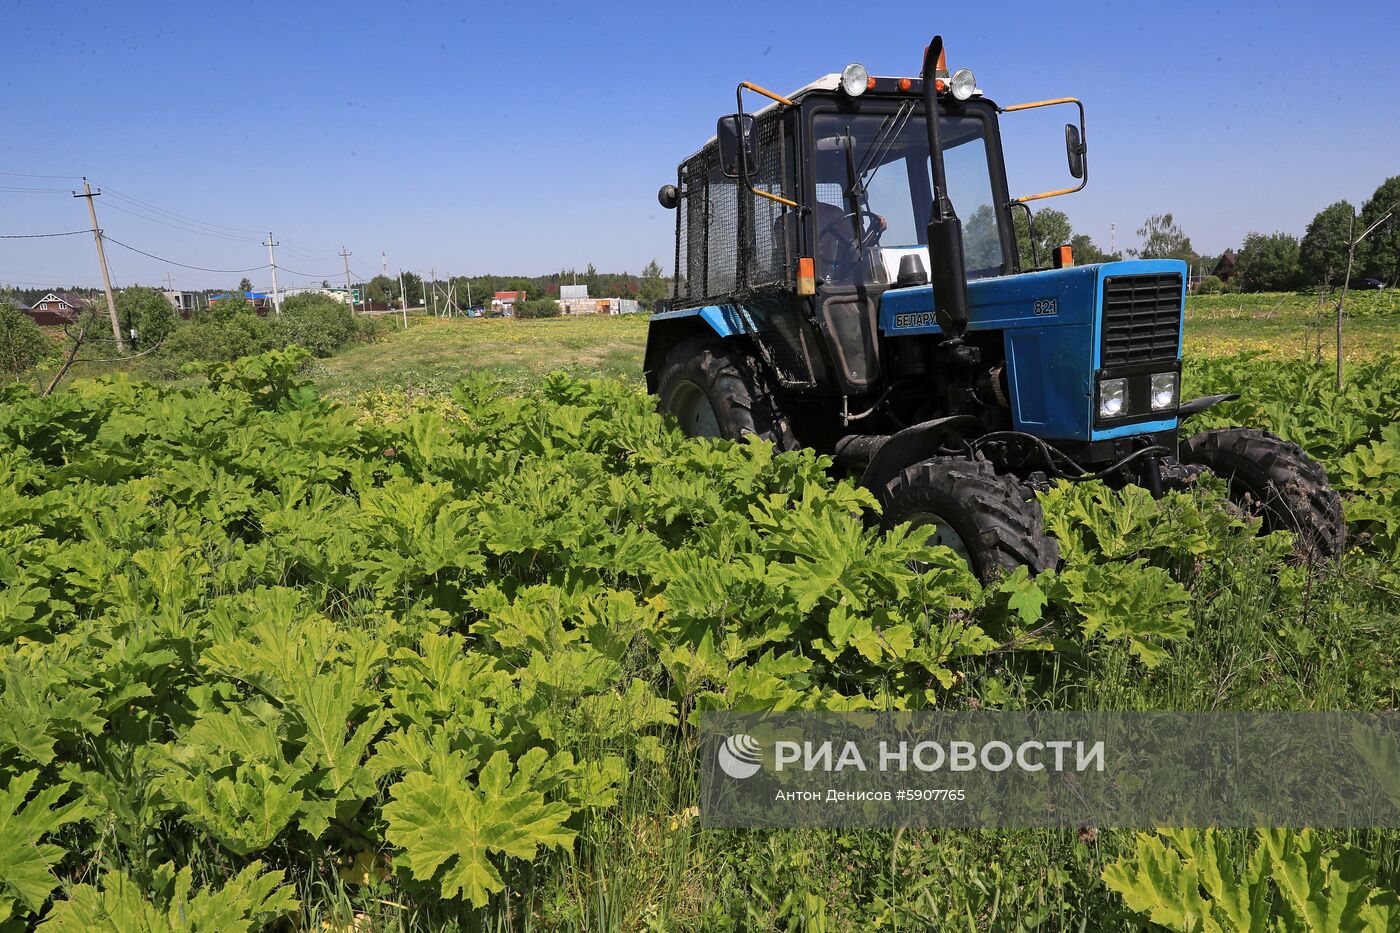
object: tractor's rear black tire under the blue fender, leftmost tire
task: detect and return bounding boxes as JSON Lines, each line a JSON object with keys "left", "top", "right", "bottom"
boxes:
{"left": 657, "top": 338, "right": 801, "bottom": 451}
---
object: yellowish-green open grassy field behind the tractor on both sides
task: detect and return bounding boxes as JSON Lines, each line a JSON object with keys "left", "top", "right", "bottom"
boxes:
{"left": 316, "top": 293, "right": 1400, "bottom": 398}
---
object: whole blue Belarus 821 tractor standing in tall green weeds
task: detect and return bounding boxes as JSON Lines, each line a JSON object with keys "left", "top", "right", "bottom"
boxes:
{"left": 644, "top": 38, "right": 1345, "bottom": 579}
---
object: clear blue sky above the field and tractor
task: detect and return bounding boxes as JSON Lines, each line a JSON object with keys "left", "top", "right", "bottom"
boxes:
{"left": 0, "top": 0, "right": 1400, "bottom": 287}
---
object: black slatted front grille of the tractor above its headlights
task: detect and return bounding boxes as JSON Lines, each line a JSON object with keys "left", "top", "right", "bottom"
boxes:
{"left": 1099, "top": 272, "right": 1182, "bottom": 368}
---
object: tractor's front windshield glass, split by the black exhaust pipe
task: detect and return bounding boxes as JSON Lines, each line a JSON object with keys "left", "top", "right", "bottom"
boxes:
{"left": 812, "top": 105, "right": 1005, "bottom": 284}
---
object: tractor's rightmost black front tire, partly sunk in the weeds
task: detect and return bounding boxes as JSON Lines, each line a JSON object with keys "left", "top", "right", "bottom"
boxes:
{"left": 1180, "top": 427, "right": 1347, "bottom": 562}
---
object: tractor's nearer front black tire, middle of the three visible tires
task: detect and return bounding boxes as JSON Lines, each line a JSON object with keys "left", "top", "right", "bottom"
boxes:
{"left": 879, "top": 457, "right": 1060, "bottom": 581}
